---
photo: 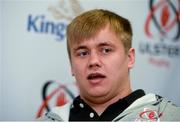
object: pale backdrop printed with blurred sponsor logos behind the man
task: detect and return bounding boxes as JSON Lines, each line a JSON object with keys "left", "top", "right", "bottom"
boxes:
{"left": 0, "top": 0, "right": 180, "bottom": 120}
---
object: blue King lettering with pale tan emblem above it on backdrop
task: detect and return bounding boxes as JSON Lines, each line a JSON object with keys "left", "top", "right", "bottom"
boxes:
{"left": 27, "top": 0, "right": 83, "bottom": 41}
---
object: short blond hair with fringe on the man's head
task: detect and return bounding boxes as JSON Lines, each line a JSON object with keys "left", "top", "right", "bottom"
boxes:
{"left": 67, "top": 9, "right": 133, "bottom": 60}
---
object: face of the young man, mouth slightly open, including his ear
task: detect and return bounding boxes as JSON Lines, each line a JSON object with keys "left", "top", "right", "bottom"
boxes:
{"left": 71, "top": 26, "right": 134, "bottom": 102}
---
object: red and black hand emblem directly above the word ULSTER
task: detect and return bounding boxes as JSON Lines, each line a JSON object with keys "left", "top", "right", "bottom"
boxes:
{"left": 145, "top": 0, "right": 180, "bottom": 41}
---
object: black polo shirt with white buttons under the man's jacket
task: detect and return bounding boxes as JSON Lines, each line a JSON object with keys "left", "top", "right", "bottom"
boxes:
{"left": 69, "top": 89, "right": 145, "bottom": 121}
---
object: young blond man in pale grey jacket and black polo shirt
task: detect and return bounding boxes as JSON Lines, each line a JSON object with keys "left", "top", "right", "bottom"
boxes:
{"left": 40, "top": 9, "right": 180, "bottom": 121}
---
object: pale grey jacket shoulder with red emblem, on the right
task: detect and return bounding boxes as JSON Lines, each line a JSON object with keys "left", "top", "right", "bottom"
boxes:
{"left": 116, "top": 93, "right": 180, "bottom": 121}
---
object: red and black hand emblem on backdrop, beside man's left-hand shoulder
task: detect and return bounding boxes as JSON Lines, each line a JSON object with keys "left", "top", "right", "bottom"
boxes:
{"left": 36, "top": 80, "right": 78, "bottom": 118}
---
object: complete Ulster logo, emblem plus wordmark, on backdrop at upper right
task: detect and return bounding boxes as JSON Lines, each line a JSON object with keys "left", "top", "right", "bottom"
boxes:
{"left": 139, "top": 0, "right": 180, "bottom": 68}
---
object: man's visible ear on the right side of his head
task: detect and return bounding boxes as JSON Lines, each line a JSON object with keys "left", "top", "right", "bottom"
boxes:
{"left": 128, "top": 48, "right": 135, "bottom": 69}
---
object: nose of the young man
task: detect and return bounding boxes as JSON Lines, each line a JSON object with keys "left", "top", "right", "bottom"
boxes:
{"left": 88, "top": 52, "right": 101, "bottom": 69}
